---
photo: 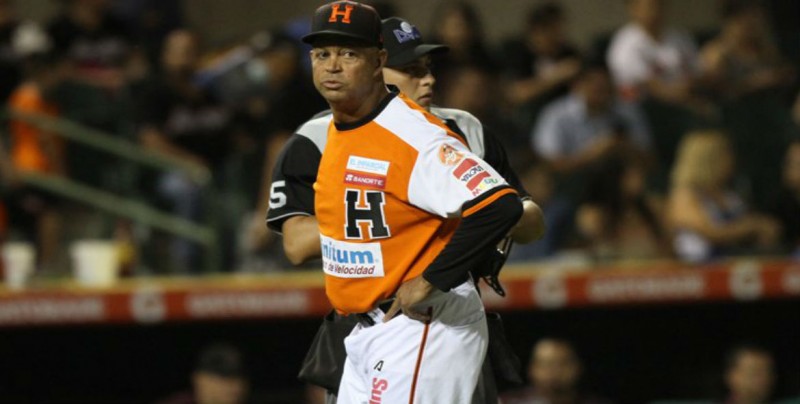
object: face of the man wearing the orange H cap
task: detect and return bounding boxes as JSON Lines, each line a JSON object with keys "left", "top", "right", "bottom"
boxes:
{"left": 311, "top": 40, "right": 385, "bottom": 106}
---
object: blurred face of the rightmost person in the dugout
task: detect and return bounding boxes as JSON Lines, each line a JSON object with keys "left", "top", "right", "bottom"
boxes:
{"left": 727, "top": 351, "right": 774, "bottom": 402}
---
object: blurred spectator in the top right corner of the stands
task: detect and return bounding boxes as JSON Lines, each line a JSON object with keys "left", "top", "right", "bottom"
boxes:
{"left": 701, "top": 0, "right": 794, "bottom": 102}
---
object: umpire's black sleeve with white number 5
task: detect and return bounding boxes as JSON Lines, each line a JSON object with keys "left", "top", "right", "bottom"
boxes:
{"left": 267, "top": 134, "right": 322, "bottom": 233}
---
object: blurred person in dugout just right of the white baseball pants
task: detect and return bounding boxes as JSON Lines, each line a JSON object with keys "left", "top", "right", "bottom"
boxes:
{"left": 501, "top": 338, "right": 606, "bottom": 404}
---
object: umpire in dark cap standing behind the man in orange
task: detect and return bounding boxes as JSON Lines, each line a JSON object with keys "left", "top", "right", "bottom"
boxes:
{"left": 267, "top": 11, "right": 544, "bottom": 404}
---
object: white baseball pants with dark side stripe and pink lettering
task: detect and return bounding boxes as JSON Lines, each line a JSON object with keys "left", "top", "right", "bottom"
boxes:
{"left": 338, "top": 281, "right": 489, "bottom": 404}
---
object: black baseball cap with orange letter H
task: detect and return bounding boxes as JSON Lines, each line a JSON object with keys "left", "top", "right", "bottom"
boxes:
{"left": 302, "top": 1, "right": 383, "bottom": 48}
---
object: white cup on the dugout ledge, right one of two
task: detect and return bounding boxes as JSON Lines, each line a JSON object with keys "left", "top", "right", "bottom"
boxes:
{"left": 70, "top": 240, "right": 119, "bottom": 287}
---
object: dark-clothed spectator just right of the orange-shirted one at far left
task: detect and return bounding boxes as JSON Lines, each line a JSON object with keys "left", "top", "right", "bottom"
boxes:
{"left": 47, "top": 0, "right": 147, "bottom": 193}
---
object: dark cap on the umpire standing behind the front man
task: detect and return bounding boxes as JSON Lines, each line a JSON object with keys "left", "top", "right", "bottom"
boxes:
{"left": 381, "top": 17, "right": 450, "bottom": 67}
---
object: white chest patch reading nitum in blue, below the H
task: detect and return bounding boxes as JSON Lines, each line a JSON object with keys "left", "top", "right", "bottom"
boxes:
{"left": 320, "top": 235, "right": 383, "bottom": 278}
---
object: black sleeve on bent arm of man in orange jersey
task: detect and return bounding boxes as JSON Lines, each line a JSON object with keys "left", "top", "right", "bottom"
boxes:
{"left": 422, "top": 187, "right": 522, "bottom": 292}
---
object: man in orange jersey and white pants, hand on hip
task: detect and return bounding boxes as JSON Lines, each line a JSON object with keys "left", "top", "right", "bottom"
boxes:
{"left": 303, "top": 1, "right": 522, "bottom": 404}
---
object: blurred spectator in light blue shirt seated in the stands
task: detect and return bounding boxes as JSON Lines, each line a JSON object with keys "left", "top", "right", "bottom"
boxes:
{"left": 531, "top": 66, "right": 651, "bottom": 177}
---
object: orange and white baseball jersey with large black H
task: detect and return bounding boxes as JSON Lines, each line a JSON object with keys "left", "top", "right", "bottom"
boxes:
{"left": 314, "top": 95, "right": 515, "bottom": 314}
